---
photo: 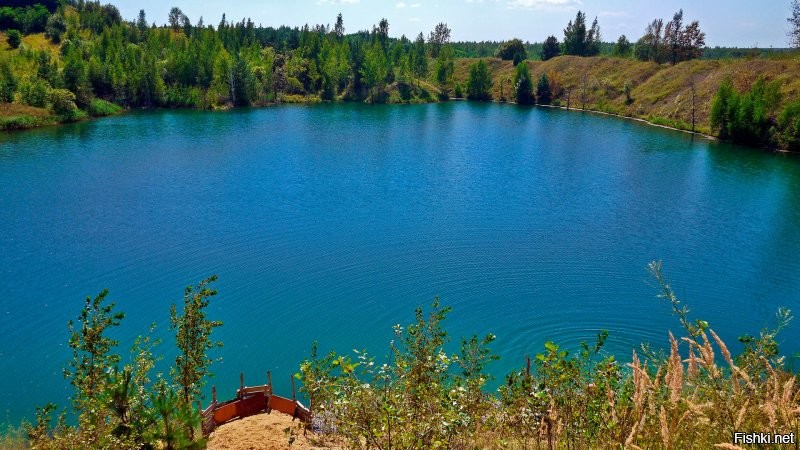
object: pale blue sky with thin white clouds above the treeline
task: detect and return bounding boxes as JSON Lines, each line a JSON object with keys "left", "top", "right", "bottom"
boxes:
{"left": 111, "top": 0, "right": 791, "bottom": 47}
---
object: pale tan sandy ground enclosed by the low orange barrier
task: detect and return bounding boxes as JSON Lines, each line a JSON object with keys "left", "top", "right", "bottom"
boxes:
{"left": 207, "top": 412, "right": 340, "bottom": 450}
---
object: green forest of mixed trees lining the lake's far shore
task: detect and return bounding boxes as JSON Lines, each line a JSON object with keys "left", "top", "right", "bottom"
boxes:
{"left": 0, "top": 0, "right": 800, "bottom": 150}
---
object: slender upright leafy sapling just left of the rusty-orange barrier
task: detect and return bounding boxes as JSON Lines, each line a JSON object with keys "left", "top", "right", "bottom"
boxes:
{"left": 170, "top": 275, "right": 222, "bottom": 405}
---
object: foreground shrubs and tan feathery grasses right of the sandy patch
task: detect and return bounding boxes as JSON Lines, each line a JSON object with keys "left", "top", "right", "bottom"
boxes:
{"left": 298, "top": 263, "right": 800, "bottom": 449}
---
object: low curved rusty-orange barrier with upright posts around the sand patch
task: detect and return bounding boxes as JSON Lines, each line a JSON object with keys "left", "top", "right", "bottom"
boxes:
{"left": 197, "top": 372, "right": 311, "bottom": 436}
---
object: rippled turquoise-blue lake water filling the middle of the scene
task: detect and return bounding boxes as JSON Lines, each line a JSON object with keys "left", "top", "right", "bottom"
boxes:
{"left": 0, "top": 102, "right": 800, "bottom": 423}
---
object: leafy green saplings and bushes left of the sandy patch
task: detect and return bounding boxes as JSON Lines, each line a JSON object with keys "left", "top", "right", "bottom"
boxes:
{"left": 24, "top": 277, "right": 221, "bottom": 450}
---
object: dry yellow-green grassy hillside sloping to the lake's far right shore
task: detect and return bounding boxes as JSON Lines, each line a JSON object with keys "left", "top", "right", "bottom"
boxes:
{"left": 455, "top": 56, "right": 800, "bottom": 134}
